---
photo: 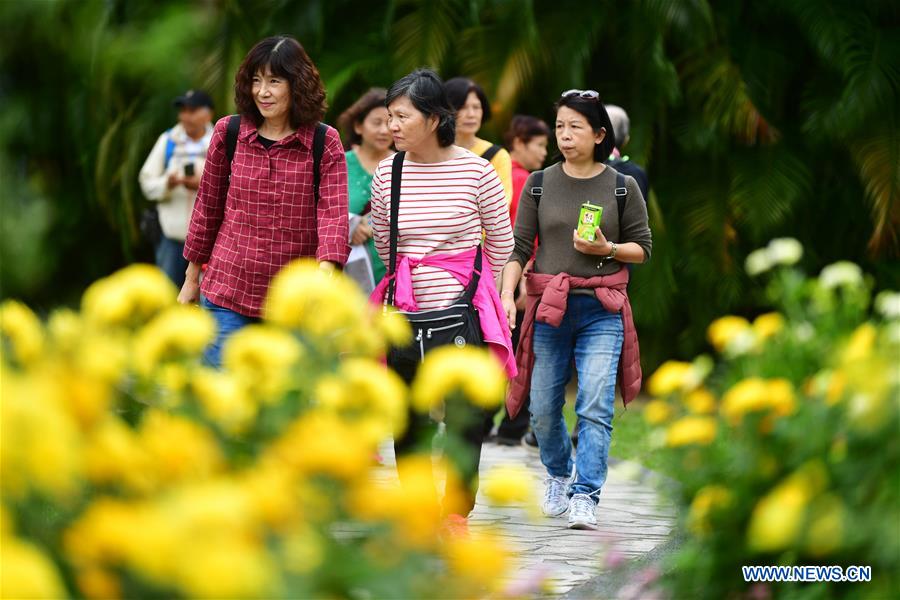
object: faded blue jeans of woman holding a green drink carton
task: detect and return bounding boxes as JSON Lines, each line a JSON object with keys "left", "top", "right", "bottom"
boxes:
{"left": 531, "top": 294, "right": 624, "bottom": 503}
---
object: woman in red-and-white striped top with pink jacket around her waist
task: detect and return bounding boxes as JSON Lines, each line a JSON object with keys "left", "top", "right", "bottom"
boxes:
{"left": 371, "top": 69, "right": 515, "bottom": 529}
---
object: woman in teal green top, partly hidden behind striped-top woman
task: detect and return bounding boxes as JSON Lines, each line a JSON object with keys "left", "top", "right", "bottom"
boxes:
{"left": 338, "top": 88, "right": 393, "bottom": 292}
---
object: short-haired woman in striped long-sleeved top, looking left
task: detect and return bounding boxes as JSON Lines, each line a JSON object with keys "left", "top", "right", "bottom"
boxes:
{"left": 371, "top": 70, "right": 515, "bottom": 523}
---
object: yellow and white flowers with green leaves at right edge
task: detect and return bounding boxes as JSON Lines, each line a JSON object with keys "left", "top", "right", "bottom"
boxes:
{"left": 644, "top": 239, "right": 900, "bottom": 599}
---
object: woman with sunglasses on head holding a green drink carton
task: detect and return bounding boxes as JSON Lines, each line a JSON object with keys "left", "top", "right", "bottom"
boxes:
{"left": 500, "top": 90, "right": 652, "bottom": 529}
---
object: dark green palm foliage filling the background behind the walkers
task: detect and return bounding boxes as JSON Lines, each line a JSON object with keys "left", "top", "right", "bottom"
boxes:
{"left": 0, "top": 0, "right": 900, "bottom": 366}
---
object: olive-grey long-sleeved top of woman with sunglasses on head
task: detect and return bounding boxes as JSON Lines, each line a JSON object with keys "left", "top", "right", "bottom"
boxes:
{"left": 509, "top": 163, "right": 653, "bottom": 277}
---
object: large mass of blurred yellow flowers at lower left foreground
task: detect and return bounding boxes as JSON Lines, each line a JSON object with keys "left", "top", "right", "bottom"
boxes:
{"left": 0, "top": 261, "right": 508, "bottom": 598}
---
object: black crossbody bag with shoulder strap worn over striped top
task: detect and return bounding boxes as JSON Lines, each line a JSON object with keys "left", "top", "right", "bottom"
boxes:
{"left": 385, "top": 152, "right": 484, "bottom": 366}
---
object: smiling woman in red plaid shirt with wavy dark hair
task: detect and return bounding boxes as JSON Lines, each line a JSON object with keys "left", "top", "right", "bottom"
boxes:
{"left": 178, "top": 36, "right": 349, "bottom": 366}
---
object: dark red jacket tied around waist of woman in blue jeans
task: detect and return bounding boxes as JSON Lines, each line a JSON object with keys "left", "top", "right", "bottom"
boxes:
{"left": 506, "top": 269, "right": 641, "bottom": 418}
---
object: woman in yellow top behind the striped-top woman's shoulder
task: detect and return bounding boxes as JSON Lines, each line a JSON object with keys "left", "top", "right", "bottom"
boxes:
{"left": 444, "top": 77, "right": 512, "bottom": 206}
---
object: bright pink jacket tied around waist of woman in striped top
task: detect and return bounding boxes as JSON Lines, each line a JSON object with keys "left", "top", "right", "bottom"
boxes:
{"left": 369, "top": 247, "right": 517, "bottom": 378}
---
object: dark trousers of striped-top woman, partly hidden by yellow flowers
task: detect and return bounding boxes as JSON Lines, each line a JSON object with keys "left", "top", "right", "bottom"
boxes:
{"left": 391, "top": 354, "right": 491, "bottom": 516}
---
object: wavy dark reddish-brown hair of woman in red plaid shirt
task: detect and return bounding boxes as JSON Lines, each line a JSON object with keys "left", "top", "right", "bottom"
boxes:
{"left": 234, "top": 35, "right": 328, "bottom": 128}
